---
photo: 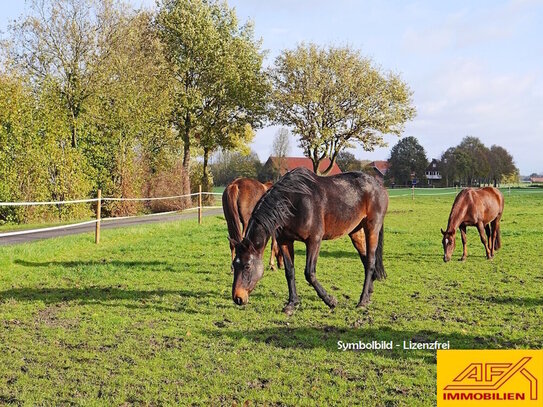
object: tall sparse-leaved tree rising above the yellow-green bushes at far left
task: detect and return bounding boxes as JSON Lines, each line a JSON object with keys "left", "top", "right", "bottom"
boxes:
{"left": 11, "top": 0, "right": 120, "bottom": 148}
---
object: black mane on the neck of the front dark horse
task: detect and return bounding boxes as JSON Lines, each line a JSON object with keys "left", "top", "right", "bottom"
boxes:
{"left": 247, "top": 168, "right": 316, "bottom": 236}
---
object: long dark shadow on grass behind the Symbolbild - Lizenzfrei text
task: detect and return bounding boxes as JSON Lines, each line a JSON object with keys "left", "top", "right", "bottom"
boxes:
{"left": 205, "top": 326, "right": 532, "bottom": 356}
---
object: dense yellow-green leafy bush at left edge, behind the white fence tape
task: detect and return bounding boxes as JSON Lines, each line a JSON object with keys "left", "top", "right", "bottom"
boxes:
{"left": 0, "top": 69, "right": 91, "bottom": 222}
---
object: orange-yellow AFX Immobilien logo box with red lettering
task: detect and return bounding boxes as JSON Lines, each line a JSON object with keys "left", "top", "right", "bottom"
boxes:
{"left": 437, "top": 350, "right": 543, "bottom": 406}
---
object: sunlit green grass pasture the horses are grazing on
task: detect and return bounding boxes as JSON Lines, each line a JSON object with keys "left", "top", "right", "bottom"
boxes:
{"left": 0, "top": 191, "right": 543, "bottom": 406}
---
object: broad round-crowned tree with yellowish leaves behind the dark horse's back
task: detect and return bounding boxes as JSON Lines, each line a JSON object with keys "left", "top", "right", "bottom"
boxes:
{"left": 270, "top": 44, "right": 415, "bottom": 174}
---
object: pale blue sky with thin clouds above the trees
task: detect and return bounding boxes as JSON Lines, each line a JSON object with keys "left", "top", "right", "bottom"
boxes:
{"left": 0, "top": 0, "right": 543, "bottom": 175}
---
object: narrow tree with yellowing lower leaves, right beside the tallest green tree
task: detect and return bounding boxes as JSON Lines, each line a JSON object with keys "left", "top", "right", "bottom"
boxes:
{"left": 195, "top": 15, "right": 269, "bottom": 191}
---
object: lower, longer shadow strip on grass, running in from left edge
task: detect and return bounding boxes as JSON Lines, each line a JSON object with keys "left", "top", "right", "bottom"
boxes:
{"left": 0, "top": 287, "right": 220, "bottom": 312}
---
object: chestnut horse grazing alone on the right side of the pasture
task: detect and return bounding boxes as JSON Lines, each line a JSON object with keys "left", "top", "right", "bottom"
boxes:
{"left": 441, "top": 187, "right": 503, "bottom": 262}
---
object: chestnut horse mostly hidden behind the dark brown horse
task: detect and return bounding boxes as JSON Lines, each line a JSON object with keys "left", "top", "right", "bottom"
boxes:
{"left": 222, "top": 178, "right": 283, "bottom": 270}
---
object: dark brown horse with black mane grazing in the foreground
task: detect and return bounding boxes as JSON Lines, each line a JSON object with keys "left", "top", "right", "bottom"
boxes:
{"left": 232, "top": 168, "right": 388, "bottom": 314}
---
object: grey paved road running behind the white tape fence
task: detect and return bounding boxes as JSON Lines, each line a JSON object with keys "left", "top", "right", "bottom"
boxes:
{"left": 0, "top": 208, "right": 223, "bottom": 246}
